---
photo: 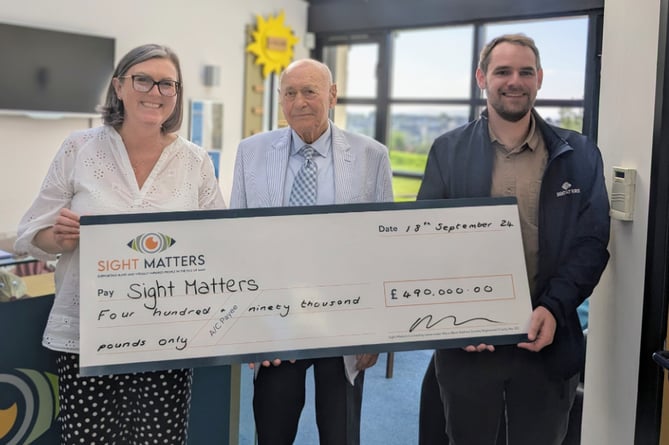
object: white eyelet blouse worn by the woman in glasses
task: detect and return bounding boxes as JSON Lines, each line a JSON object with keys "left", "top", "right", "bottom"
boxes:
{"left": 15, "top": 126, "right": 225, "bottom": 353}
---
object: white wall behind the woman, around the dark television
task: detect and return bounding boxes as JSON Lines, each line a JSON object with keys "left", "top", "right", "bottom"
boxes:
{"left": 0, "top": 0, "right": 308, "bottom": 241}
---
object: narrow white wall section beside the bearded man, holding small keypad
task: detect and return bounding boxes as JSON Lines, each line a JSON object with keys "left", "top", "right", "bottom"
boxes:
{"left": 582, "top": 0, "right": 660, "bottom": 445}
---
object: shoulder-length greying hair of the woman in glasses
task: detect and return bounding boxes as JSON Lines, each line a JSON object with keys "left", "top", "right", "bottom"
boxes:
{"left": 100, "top": 43, "right": 183, "bottom": 133}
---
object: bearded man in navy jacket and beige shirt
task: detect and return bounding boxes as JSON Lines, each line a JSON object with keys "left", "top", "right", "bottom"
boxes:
{"left": 418, "top": 34, "right": 609, "bottom": 445}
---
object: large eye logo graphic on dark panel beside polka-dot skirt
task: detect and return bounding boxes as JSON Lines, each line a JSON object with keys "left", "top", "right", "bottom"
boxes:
{"left": 0, "top": 369, "right": 60, "bottom": 445}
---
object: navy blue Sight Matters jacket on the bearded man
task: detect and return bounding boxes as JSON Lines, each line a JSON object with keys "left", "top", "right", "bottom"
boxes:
{"left": 418, "top": 110, "right": 610, "bottom": 378}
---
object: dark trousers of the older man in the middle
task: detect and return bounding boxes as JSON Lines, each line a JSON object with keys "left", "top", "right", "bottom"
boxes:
{"left": 253, "top": 357, "right": 364, "bottom": 445}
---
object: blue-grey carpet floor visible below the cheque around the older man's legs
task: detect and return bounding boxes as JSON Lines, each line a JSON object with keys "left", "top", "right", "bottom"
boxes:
{"left": 239, "top": 351, "right": 432, "bottom": 445}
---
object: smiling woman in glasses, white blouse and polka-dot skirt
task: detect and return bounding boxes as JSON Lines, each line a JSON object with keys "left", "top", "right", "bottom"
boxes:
{"left": 16, "top": 45, "right": 224, "bottom": 444}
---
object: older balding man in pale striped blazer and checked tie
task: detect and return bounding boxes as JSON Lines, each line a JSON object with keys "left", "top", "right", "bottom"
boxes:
{"left": 230, "top": 59, "right": 393, "bottom": 445}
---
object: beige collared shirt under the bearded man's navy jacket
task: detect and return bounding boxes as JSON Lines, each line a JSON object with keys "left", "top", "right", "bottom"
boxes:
{"left": 488, "top": 116, "right": 548, "bottom": 293}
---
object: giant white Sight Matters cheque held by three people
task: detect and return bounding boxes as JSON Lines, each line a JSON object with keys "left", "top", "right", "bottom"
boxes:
{"left": 80, "top": 198, "right": 532, "bottom": 375}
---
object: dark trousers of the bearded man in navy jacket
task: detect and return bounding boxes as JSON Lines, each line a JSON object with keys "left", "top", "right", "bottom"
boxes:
{"left": 435, "top": 345, "right": 578, "bottom": 445}
